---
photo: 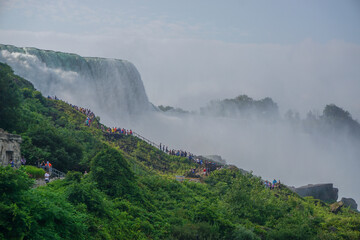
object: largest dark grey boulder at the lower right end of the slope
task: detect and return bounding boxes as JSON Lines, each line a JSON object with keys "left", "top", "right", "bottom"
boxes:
{"left": 294, "top": 183, "right": 339, "bottom": 202}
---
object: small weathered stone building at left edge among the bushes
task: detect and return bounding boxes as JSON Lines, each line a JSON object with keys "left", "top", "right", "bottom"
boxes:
{"left": 0, "top": 128, "right": 22, "bottom": 167}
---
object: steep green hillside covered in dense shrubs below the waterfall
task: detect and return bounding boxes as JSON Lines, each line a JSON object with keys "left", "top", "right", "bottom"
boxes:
{"left": 0, "top": 63, "right": 360, "bottom": 239}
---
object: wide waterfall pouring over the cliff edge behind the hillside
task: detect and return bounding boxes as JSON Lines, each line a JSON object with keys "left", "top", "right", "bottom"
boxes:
{"left": 0, "top": 44, "right": 151, "bottom": 125}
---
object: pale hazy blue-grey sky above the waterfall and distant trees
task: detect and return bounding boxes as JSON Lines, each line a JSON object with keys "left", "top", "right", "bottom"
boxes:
{"left": 0, "top": 0, "right": 360, "bottom": 120}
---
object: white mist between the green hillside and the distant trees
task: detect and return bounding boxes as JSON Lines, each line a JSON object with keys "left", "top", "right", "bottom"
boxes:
{"left": 129, "top": 110, "right": 360, "bottom": 206}
